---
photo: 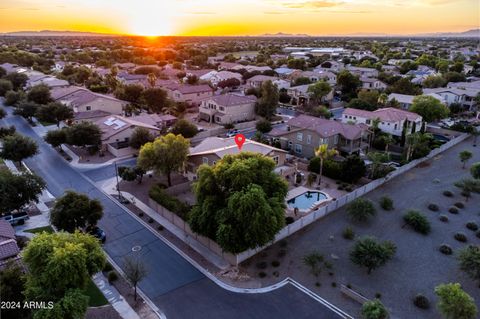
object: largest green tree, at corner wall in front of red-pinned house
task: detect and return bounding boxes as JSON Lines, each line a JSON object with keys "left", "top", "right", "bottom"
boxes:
{"left": 189, "top": 152, "right": 288, "bottom": 253}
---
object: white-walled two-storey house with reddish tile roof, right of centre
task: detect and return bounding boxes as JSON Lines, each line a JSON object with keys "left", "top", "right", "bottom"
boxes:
{"left": 342, "top": 107, "right": 422, "bottom": 136}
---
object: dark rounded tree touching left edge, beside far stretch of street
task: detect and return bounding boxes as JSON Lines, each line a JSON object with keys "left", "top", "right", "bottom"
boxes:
{"left": 0, "top": 133, "right": 38, "bottom": 163}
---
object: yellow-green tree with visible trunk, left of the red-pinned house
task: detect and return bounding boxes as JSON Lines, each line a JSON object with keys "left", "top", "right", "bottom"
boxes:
{"left": 138, "top": 133, "right": 190, "bottom": 186}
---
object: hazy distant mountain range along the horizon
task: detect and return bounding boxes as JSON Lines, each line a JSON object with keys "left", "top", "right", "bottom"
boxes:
{"left": 0, "top": 29, "right": 480, "bottom": 38}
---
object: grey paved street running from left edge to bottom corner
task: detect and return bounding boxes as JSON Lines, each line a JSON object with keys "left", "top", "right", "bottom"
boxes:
{"left": 0, "top": 103, "right": 348, "bottom": 318}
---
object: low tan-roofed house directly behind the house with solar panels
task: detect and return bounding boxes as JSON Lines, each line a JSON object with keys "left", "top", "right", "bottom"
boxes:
{"left": 51, "top": 86, "right": 127, "bottom": 114}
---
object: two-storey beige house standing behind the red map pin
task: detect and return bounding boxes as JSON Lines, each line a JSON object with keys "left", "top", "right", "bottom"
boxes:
{"left": 199, "top": 93, "right": 257, "bottom": 125}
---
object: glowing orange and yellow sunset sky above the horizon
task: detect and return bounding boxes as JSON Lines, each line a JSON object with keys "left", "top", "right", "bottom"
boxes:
{"left": 0, "top": 0, "right": 480, "bottom": 35}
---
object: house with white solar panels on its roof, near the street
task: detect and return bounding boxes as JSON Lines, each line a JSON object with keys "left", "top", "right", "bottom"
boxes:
{"left": 94, "top": 115, "right": 160, "bottom": 157}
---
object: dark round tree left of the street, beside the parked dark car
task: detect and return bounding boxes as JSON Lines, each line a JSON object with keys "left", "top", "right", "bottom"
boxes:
{"left": 50, "top": 191, "right": 103, "bottom": 233}
